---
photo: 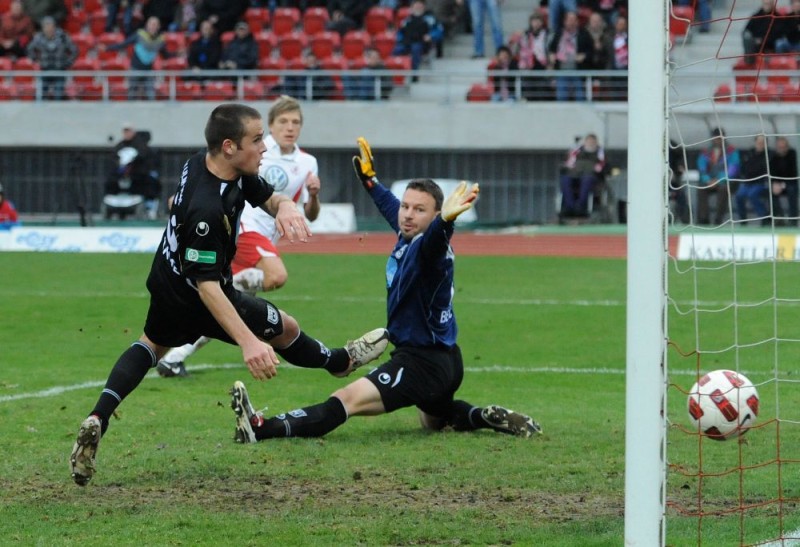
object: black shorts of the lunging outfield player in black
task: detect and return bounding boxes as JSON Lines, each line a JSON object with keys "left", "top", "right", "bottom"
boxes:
{"left": 144, "top": 291, "right": 283, "bottom": 348}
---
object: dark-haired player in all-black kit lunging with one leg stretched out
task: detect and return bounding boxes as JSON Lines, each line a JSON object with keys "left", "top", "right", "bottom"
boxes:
{"left": 70, "top": 104, "right": 388, "bottom": 486}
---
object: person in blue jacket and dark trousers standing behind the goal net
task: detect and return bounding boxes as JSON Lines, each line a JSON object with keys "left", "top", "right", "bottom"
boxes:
{"left": 697, "top": 128, "right": 741, "bottom": 225}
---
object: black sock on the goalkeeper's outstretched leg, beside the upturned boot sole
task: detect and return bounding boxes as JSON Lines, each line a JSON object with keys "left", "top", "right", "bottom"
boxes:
{"left": 253, "top": 397, "right": 347, "bottom": 441}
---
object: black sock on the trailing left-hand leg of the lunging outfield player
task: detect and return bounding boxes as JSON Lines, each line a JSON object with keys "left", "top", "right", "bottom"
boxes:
{"left": 90, "top": 342, "right": 156, "bottom": 433}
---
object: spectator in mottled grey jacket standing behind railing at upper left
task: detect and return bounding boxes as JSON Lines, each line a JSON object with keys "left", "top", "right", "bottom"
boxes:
{"left": 28, "top": 15, "right": 78, "bottom": 101}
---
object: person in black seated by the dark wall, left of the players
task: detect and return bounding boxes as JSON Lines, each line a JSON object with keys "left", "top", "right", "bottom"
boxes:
{"left": 104, "top": 123, "right": 161, "bottom": 220}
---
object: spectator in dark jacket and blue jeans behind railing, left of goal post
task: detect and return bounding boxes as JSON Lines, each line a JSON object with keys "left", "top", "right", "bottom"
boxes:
{"left": 549, "top": 11, "right": 592, "bottom": 101}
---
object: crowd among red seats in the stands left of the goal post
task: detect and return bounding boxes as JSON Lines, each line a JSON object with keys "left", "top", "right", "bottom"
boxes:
{"left": 0, "top": 0, "right": 627, "bottom": 100}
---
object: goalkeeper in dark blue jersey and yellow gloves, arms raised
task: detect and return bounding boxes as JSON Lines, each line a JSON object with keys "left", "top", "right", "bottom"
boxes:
{"left": 231, "top": 137, "right": 541, "bottom": 443}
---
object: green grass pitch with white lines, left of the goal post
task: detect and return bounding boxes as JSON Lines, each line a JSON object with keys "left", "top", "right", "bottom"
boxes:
{"left": 0, "top": 253, "right": 792, "bottom": 546}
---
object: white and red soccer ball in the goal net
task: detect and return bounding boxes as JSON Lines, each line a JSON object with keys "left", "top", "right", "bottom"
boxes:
{"left": 689, "top": 370, "right": 758, "bottom": 441}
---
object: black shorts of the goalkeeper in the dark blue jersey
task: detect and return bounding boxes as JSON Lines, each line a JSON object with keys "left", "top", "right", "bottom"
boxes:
{"left": 365, "top": 346, "right": 464, "bottom": 417}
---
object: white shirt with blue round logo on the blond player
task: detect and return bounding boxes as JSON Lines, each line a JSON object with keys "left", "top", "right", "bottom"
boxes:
{"left": 239, "top": 135, "right": 318, "bottom": 244}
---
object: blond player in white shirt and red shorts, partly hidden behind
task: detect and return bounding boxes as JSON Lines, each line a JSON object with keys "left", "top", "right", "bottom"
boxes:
{"left": 157, "top": 95, "right": 320, "bottom": 377}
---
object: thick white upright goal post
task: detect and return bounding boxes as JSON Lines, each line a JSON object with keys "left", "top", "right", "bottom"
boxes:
{"left": 625, "top": 1, "right": 670, "bottom": 546}
